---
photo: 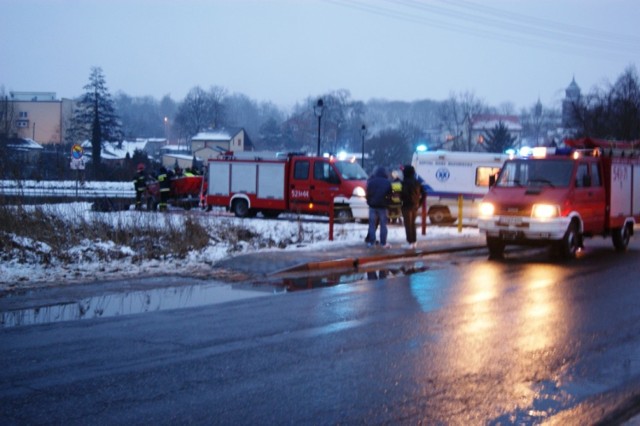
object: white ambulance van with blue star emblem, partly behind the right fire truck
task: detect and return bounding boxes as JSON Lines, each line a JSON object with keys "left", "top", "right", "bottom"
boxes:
{"left": 411, "top": 151, "right": 509, "bottom": 225}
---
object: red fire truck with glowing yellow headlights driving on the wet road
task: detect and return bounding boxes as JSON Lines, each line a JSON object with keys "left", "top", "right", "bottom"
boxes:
{"left": 478, "top": 138, "right": 640, "bottom": 259}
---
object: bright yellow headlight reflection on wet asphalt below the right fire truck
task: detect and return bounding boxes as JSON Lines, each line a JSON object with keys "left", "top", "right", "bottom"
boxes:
{"left": 409, "top": 262, "right": 572, "bottom": 424}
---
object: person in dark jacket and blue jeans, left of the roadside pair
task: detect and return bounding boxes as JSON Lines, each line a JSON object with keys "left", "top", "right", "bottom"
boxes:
{"left": 367, "top": 167, "right": 391, "bottom": 248}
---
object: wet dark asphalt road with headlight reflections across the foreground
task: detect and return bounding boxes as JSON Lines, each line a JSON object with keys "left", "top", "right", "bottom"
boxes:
{"left": 0, "top": 238, "right": 640, "bottom": 424}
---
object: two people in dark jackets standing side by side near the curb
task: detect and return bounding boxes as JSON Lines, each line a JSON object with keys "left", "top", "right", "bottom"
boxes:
{"left": 366, "top": 165, "right": 426, "bottom": 248}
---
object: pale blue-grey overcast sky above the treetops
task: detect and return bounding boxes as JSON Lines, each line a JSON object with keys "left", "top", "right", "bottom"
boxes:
{"left": 0, "top": 0, "right": 640, "bottom": 109}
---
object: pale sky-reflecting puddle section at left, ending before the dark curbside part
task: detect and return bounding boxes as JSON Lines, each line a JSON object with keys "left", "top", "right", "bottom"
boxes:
{"left": 0, "top": 283, "right": 275, "bottom": 328}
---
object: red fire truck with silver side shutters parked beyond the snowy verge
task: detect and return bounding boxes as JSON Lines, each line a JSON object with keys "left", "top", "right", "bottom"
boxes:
{"left": 206, "top": 152, "right": 369, "bottom": 221}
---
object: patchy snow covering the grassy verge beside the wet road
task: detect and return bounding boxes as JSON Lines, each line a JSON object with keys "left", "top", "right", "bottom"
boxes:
{"left": 0, "top": 180, "right": 478, "bottom": 292}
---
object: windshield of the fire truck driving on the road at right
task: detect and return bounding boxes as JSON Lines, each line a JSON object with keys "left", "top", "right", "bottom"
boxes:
{"left": 496, "top": 159, "right": 573, "bottom": 187}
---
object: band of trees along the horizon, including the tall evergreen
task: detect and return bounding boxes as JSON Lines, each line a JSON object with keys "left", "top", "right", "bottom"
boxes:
{"left": 0, "top": 66, "right": 640, "bottom": 180}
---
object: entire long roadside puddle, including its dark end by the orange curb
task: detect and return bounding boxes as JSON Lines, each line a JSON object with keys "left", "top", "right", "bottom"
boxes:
{"left": 0, "top": 261, "right": 428, "bottom": 328}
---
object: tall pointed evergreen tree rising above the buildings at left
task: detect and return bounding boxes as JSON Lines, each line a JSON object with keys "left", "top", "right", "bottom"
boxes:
{"left": 70, "top": 67, "right": 122, "bottom": 177}
